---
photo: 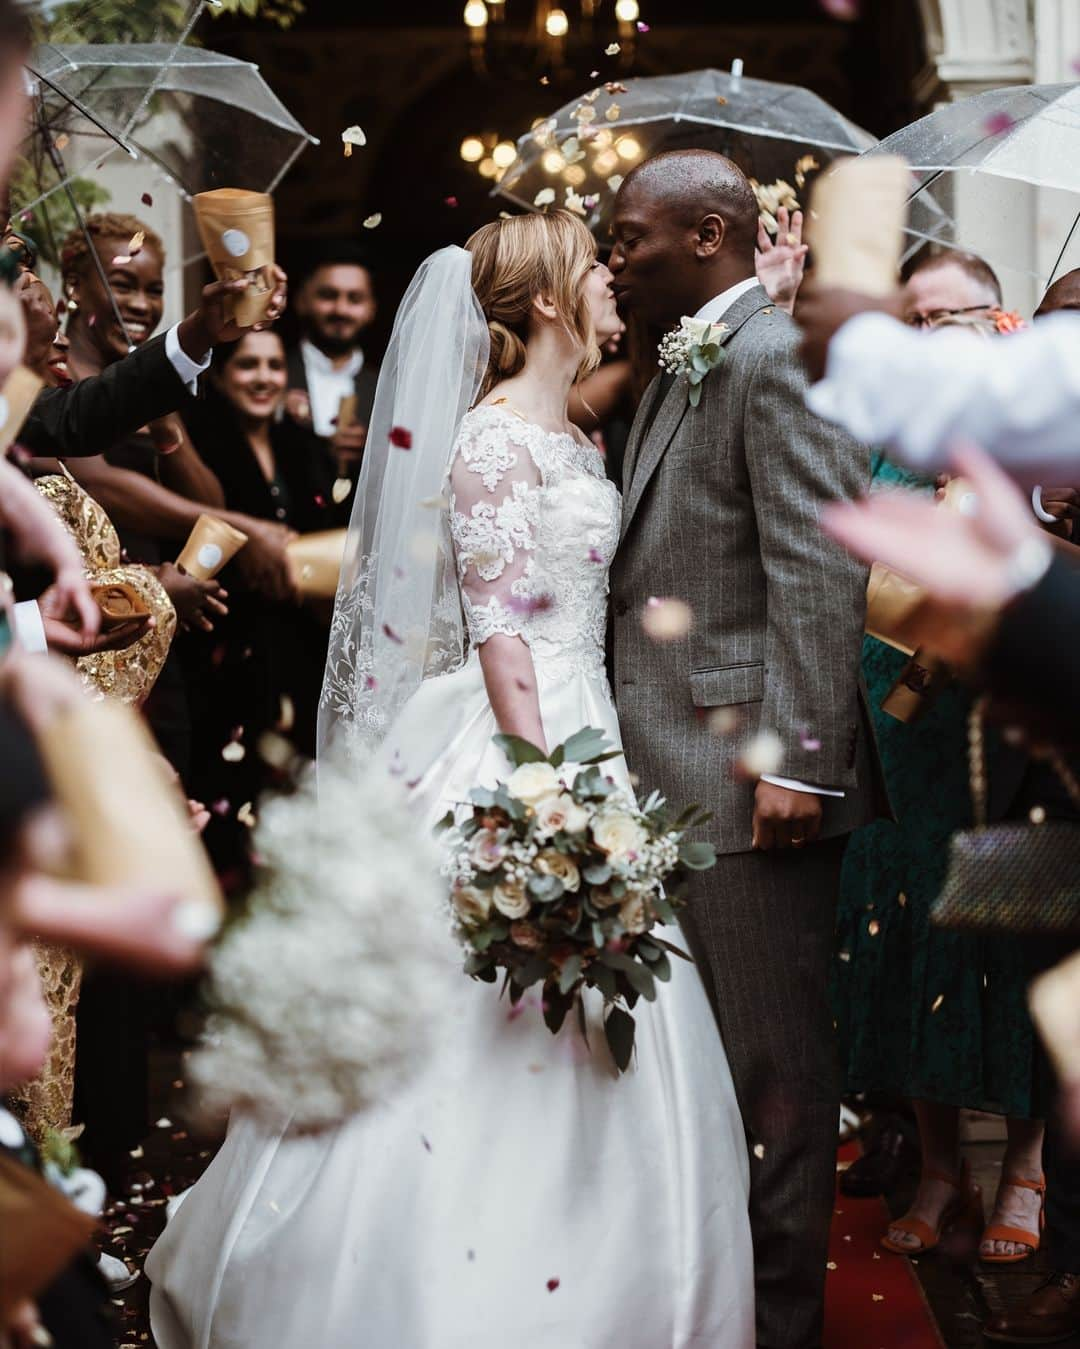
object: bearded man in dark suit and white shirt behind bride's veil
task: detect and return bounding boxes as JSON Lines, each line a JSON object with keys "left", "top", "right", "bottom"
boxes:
{"left": 286, "top": 241, "right": 379, "bottom": 509}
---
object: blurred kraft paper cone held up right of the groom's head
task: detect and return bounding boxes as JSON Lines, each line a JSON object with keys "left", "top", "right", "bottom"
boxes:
{"left": 806, "top": 155, "right": 911, "bottom": 297}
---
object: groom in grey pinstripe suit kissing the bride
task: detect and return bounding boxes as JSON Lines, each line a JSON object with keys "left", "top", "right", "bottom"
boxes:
{"left": 609, "top": 150, "right": 876, "bottom": 1349}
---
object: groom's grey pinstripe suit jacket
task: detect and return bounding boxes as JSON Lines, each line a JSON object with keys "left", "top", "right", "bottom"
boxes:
{"left": 611, "top": 286, "right": 880, "bottom": 853}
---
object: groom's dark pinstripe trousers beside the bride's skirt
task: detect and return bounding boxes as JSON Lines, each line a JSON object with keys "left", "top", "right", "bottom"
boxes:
{"left": 684, "top": 839, "right": 847, "bottom": 1349}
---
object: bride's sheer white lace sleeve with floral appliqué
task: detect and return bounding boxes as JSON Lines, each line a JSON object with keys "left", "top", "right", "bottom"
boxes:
{"left": 450, "top": 417, "right": 542, "bottom": 646}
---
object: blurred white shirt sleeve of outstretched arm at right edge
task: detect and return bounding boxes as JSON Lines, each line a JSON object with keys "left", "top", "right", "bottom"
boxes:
{"left": 806, "top": 313, "right": 1080, "bottom": 487}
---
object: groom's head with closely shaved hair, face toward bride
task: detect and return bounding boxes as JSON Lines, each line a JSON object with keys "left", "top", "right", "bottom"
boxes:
{"left": 611, "top": 150, "right": 758, "bottom": 325}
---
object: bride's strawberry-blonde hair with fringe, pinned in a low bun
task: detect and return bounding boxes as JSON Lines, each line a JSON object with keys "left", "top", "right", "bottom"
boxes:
{"left": 465, "top": 210, "right": 600, "bottom": 398}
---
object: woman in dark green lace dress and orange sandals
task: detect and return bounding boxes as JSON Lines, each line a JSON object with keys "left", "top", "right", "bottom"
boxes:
{"left": 835, "top": 455, "right": 1044, "bottom": 1257}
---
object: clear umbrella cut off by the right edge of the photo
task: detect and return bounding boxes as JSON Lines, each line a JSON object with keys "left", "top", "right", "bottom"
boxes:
{"left": 867, "top": 84, "right": 1080, "bottom": 281}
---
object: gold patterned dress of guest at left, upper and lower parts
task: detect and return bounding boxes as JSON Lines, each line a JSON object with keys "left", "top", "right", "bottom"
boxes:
{"left": 11, "top": 472, "right": 177, "bottom": 1144}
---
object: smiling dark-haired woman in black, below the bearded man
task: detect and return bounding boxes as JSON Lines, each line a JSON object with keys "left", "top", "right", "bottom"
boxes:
{"left": 180, "top": 331, "right": 332, "bottom": 865}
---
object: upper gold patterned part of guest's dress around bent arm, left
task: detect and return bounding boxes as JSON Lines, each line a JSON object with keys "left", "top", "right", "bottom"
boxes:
{"left": 35, "top": 473, "right": 177, "bottom": 704}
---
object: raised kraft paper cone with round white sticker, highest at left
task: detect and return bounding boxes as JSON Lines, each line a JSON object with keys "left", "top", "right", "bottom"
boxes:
{"left": 193, "top": 188, "right": 274, "bottom": 328}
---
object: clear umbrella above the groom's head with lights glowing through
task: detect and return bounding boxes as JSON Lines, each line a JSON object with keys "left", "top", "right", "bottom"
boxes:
{"left": 495, "top": 61, "right": 874, "bottom": 228}
